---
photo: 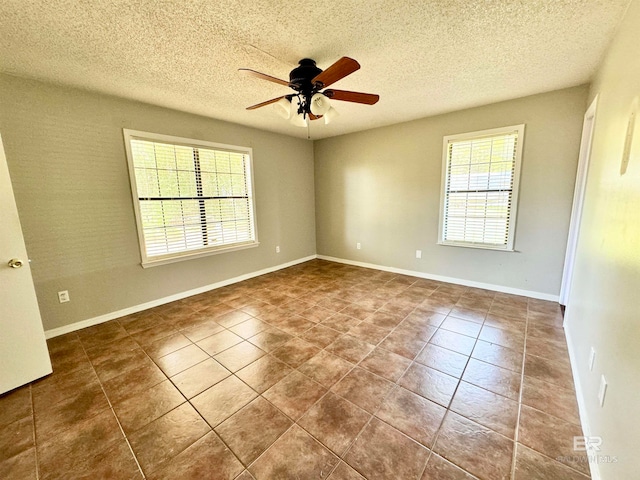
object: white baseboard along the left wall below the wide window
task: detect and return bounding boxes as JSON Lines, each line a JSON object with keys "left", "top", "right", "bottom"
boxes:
{"left": 44, "top": 255, "right": 316, "bottom": 338}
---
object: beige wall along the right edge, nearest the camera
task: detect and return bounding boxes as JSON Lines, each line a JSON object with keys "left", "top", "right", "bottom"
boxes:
{"left": 565, "top": 0, "right": 640, "bottom": 480}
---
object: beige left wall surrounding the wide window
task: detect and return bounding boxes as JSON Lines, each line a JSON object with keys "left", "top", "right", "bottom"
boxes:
{"left": 0, "top": 76, "right": 315, "bottom": 330}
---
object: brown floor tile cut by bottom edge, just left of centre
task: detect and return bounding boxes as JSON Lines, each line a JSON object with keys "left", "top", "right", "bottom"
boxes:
{"left": 249, "top": 425, "right": 338, "bottom": 480}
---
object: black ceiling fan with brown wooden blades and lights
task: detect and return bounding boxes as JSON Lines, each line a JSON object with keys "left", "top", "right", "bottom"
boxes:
{"left": 239, "top": 57, "right": 380, "bottom": 127}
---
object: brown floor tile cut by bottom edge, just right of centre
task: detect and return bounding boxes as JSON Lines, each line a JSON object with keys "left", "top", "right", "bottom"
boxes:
{"left": 345, "top": 418, "right": 429, "bottom": 480}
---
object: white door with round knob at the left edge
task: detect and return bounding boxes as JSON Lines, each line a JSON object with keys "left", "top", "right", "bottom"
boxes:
{"left": 0, "top": 137, "right": 52, "bottom": 394}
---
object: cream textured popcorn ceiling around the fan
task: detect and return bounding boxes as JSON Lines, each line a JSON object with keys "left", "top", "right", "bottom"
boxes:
{"left": 0, "top": 0, "right": 629, "bottom": 138}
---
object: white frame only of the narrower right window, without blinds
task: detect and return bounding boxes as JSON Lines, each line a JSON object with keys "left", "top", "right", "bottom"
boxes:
{"left": 437, "top": 124, "right": 525, "bottom": 252}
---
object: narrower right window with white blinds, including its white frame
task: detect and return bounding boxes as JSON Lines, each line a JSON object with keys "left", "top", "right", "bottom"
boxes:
{"left": 438, "top": 125, "right": 524, "bottom": 251}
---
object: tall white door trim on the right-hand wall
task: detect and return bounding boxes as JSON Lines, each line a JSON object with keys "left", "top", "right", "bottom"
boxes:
{"left": 560, "top": 95, "right": 598, "bottom": 305}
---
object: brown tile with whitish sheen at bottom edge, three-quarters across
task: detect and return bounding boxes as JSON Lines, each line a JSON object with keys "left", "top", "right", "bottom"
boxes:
{"left": 433, "top": 412, "right": 513, "bottom": 480}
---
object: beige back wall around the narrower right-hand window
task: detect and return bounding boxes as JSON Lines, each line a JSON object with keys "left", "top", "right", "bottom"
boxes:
{"left": 314, "top": 86, "right": 587, "bottom": 296}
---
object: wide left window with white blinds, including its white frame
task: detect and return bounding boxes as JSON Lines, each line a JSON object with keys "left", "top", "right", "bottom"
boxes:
{"left": 124, "top": 129, "right": 258, "bottom": 266}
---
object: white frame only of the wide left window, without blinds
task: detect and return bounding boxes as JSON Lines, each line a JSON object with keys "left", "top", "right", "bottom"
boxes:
{"left": 122, "top": 128, "right": 260, "bottom": 268}
